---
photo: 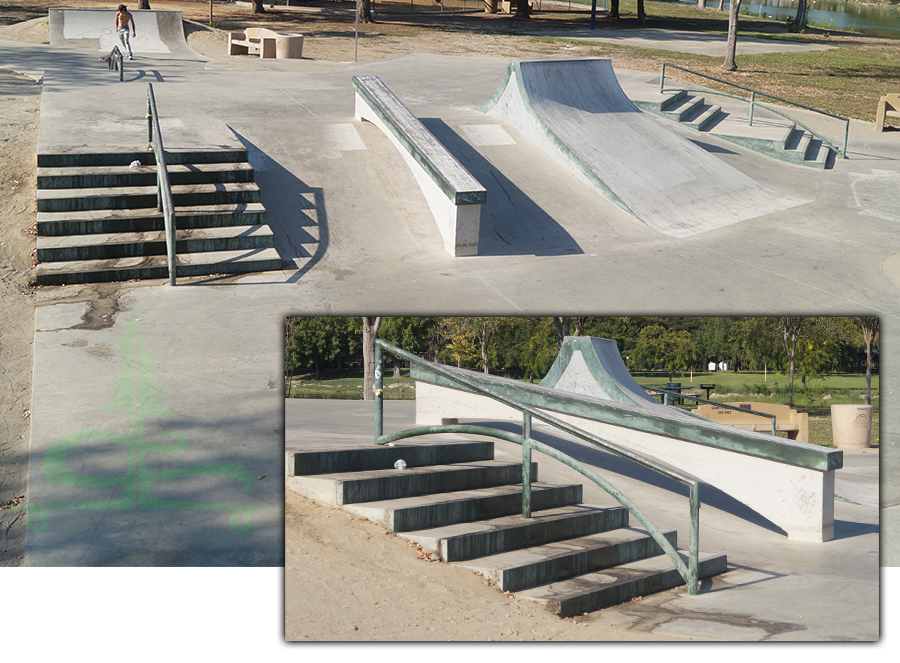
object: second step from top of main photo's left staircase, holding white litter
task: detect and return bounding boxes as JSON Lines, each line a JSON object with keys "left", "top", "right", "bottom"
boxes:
{"left": 37, "top": 162, "right": 253, "bottom": 189}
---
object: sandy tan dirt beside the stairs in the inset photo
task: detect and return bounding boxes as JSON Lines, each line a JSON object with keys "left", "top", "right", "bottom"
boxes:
{"left": 284, "top": 491, "right": 699, "bottom": 642}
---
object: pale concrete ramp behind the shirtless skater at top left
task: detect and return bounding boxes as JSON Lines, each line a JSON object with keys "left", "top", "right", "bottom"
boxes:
{"left": 49, "top": 9, "right": 189, "bottom": 55}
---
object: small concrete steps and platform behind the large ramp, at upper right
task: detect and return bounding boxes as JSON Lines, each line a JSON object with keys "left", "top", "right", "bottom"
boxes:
{"left": 634, "top": 90, "right": 835, "bottom": 168}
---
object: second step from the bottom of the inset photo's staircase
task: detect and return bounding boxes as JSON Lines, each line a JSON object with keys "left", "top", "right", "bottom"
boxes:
{"left": 460, "top": 528, "right": 677, "bottom": 592}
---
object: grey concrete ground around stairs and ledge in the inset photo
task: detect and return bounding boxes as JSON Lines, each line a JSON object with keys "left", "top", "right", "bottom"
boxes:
{"left": 285, "top": 399, "right": 879, "bottom": 641}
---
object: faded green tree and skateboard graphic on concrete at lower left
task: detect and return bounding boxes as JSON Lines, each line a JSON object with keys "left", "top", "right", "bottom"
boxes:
{"left": 20, "top": 311, "right": 260, "bottom": 532}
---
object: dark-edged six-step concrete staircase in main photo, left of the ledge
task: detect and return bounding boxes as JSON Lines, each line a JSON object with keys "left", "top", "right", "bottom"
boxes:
{"left": 36, "top": 149, "right": 281, "bottom": 285}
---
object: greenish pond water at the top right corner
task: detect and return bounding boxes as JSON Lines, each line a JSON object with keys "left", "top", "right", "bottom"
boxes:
{"left": 680, "top": 0, "right": 900, "bottom": 38}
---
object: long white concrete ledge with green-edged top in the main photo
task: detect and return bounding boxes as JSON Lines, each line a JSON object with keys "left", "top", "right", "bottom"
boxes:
{"left": 353, "top": 76, "right": 487, "bottom": 256}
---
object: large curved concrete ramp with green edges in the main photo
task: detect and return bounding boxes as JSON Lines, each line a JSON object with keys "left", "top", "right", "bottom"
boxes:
{"left": 479, "top": 58, "right": 804, "bottom": 237}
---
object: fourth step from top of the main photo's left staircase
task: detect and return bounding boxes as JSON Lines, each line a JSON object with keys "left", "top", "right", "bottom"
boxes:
{"left": 37, "top": 203, "right": 267, "bottom": 236}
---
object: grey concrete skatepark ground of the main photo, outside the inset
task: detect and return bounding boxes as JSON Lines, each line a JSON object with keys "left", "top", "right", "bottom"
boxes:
{"left": 0, "top": 15, "right": 900, "bottom": 565}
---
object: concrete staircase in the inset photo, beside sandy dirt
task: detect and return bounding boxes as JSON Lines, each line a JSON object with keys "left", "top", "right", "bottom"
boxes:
{"left": 286, "top": 442, "right": 726, "bottom": 617}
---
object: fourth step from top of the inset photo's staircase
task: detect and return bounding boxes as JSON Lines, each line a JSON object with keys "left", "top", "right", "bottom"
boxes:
{"left": 401, "top": 504, "right": 628, "bottom": 562}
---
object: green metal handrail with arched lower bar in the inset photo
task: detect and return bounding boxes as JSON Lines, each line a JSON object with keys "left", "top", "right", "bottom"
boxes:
{"left": 375, "top": 339, "right": 700, "bottom": 595}
